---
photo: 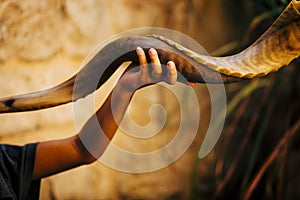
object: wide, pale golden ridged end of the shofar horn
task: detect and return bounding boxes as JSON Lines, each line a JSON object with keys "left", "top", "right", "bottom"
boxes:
{"left": 179, "top": 0, "right": 300, "bottom": 78}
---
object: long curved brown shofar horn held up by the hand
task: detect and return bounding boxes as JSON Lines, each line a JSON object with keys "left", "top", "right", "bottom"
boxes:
{"left": 0, "top": 0, "right": 300, "bottom": 113}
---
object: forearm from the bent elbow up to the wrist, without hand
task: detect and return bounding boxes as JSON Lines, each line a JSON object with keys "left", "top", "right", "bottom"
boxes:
{"left": 78, "top": 85, "right": 134, "bottom": 163}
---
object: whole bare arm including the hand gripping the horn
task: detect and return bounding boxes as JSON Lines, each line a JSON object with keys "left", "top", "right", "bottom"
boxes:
{"left": 33, "top": 47, "right": 177, "bottom": 179}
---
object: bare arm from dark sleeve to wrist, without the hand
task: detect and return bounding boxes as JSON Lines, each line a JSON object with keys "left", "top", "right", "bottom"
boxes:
{"left": 33, "top": 85, "right": 133, "bottom": 179}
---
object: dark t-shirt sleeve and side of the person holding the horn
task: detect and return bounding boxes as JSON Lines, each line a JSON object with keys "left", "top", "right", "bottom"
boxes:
{"left": 0, "top": 144, "right": 40, "bottom": 199}
